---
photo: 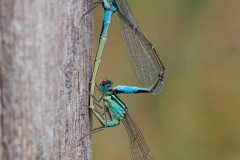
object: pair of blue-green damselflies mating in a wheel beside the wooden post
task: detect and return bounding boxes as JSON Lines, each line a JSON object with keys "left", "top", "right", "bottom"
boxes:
{"left": 81, "top": 0, "right": 165, "bottom": 160}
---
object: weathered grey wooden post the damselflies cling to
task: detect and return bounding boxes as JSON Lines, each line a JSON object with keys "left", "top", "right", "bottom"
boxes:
{"left": 0, "top": 0, "right": 93, "bottom": 160}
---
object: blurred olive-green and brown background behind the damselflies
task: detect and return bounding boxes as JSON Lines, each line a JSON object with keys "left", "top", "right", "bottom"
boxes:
{"left": 93, "top": 0, "right": 240, "bottom": 160}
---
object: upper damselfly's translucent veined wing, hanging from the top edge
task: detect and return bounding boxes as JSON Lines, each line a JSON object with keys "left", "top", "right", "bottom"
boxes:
{"left": 113, "top": 0, "right": 165, "bottom": 94}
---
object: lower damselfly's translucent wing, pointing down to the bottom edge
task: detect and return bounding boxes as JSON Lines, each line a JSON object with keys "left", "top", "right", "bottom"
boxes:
{"left": 122, "top": 113, "right": 155, "bottom": 160}
